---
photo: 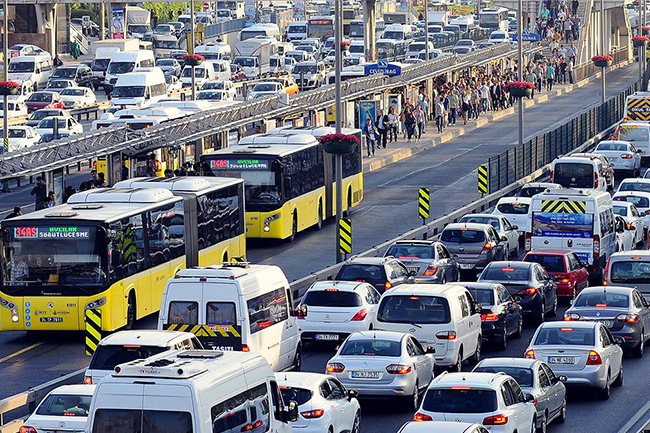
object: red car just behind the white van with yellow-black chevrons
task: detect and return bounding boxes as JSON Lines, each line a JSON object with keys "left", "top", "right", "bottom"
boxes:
{"left": 524, "top": 250, "right": 589, "bottom": 299}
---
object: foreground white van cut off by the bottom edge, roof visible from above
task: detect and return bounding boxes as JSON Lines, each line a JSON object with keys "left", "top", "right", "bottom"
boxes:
{"left": 86, "top": 350, "right": 298, "bottom": 433}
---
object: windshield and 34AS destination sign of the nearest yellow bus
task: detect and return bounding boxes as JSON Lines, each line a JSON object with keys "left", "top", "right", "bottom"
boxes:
{"left": 2, "top": 223, "right": 107, "bottom": 295}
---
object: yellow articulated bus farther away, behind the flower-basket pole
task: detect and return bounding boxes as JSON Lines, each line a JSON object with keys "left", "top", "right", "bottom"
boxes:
{"left": 201, "top": 131, "right": 363, "bottom": 240}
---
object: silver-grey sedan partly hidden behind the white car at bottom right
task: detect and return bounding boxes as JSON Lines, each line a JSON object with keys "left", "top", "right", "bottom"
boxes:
{"left": 472, "top": 358, "right": 566, "bottom": 432}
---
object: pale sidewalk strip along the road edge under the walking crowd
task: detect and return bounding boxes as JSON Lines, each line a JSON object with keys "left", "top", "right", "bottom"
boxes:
{"left": 362, "top": 61, "right": 638, "bottom": 173}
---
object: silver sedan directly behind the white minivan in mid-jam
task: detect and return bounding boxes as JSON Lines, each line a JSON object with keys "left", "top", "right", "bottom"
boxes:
{"left": 326, "top": 331, "right": 435, "bottom": 412}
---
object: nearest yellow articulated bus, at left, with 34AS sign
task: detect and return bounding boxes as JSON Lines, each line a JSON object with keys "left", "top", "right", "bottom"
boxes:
{"left": 0, "top": 178, "right": 245, "bottom": 331}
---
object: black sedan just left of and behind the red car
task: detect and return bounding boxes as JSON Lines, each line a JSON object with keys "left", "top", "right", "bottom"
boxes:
{"left": 478, "top": 262, "right": 557, "bottom": 323}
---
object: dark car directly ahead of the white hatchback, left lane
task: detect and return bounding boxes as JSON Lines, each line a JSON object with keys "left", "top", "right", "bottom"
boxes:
{"left": 334, "top": 257, "right": 410, "bottom": 293}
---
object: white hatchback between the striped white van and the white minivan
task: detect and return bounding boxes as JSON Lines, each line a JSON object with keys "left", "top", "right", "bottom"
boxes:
{"left": 297, "top": 281, "right": 381, "bottom": 342}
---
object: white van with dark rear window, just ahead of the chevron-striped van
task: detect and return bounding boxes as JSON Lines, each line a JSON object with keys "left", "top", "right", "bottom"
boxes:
{"left": 550, "top": 155, "right": 609, "bottom": 191}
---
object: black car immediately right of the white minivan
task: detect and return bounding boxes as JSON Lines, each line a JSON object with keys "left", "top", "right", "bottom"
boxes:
{"left": 461, "top": 283, "right": 524, "bottom": 350}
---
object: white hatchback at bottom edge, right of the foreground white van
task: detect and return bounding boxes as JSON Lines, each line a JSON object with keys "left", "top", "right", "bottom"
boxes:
{"left": 275, "top": 372, "right": 361, "bottom": 433}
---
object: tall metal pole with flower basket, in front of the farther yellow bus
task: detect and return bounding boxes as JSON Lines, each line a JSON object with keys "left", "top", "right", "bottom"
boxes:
{"left": 334, "top": 0, "right": 344, "bottom": 263}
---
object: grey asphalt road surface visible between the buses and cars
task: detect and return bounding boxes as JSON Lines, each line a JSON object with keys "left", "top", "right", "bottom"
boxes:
{"left": 0, "top": 61, "right": 650, "bottom": 433}
